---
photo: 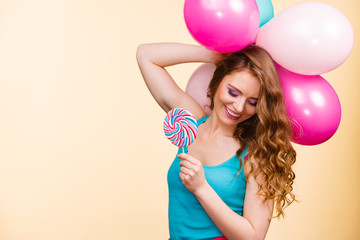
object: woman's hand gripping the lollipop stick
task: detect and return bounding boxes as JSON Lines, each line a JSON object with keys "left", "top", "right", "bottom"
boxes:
{"left": 178, "top": 153, "right": 208, "bottom": 194}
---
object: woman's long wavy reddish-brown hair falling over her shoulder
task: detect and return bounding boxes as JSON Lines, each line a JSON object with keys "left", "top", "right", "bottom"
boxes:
{"left": 207, "top": 46, "right": 296, "bottom": 218}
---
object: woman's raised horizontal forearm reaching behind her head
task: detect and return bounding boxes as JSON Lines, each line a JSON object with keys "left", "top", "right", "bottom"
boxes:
{"left": 137, "top": 43, "right": 223, "bottom": 67}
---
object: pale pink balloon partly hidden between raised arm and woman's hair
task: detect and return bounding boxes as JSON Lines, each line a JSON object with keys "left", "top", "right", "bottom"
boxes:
{"left": 185, "top": 63, "right": 215, "bottom": 115}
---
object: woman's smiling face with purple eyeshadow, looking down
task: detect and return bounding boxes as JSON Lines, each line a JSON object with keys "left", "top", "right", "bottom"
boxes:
{"left": 213, "top": 71, "right": 260, "bottom": 126}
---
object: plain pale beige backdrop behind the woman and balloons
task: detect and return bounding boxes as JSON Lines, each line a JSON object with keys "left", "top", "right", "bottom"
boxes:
{"left": 0, "top": 0, "right": 360, "bottom": 240}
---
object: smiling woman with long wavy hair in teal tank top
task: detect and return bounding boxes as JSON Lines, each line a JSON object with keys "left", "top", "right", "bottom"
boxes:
{"left": 137, "top": 43, "right": 296, "bottom": 240}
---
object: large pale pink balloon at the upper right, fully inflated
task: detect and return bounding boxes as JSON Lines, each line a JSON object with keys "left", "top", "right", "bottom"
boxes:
{"left": 256, "top": 2, "right": 354, "bottom": 75}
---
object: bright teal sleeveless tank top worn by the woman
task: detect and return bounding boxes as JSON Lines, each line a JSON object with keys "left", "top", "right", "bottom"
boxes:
{"left": 167, "top": 116, "right": 247, "bottom": 240}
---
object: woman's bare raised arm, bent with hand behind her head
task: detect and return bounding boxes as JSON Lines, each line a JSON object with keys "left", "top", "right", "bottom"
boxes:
{"left": 136, "top": 43, "right": 223, "bottom": 119}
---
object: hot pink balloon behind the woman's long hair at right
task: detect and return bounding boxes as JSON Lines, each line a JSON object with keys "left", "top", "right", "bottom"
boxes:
{"left": 276, "top": 65, "right": 341, "bottom": 145}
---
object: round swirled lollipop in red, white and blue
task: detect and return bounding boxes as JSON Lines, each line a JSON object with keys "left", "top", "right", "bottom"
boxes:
{"left": 164, "top": 108, "right": 197, "bottom": 151}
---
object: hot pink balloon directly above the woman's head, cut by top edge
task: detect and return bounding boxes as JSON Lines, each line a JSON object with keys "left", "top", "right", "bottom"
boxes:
{"left": 184, "top": 0, "right": 260, "bottom": 53}
